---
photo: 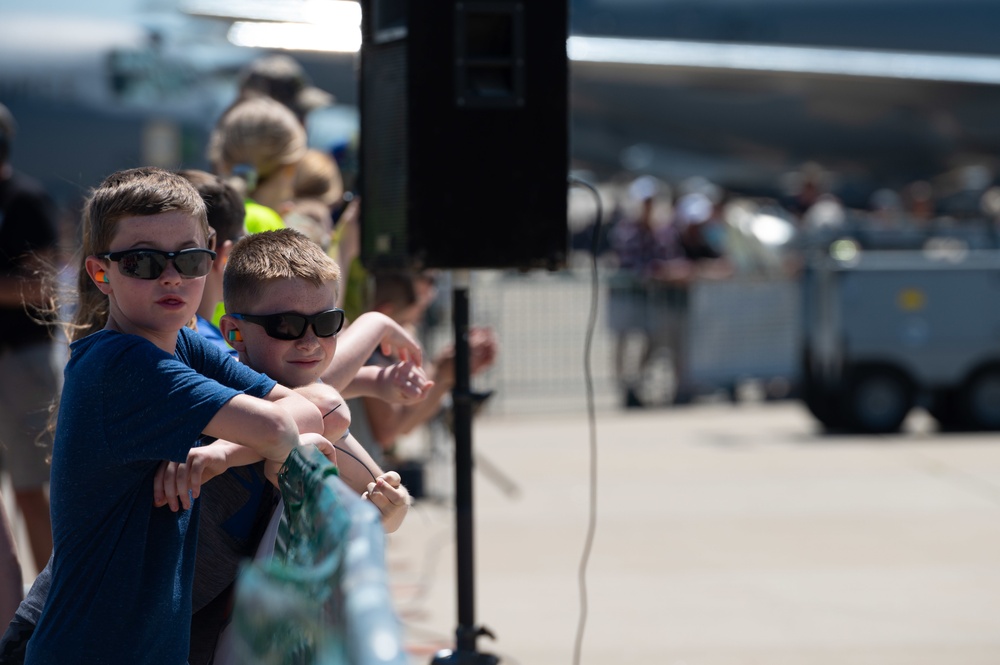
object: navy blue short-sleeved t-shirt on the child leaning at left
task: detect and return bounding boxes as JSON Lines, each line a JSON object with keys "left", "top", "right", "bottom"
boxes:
{"left": 26, "top": 328, "right": 275, "bottom": 665}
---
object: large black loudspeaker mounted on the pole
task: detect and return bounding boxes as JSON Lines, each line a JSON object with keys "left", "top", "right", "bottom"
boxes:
{"left": 358, "top": 0, "right": 569, "bottom": 270}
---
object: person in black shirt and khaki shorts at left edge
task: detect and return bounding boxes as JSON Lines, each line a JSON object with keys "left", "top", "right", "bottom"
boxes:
{"left": 0, "top": 104, "right": 60, "bottom": 574}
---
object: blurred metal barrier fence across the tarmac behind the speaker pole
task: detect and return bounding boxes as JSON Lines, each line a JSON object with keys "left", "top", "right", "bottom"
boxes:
{"left": 418, "top": 269, "right": 800, "bottom": 414}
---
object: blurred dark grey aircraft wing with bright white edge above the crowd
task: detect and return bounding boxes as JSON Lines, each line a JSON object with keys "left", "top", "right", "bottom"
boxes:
{"left": 567, "top": 35, "right": 1000, "bottom": 202}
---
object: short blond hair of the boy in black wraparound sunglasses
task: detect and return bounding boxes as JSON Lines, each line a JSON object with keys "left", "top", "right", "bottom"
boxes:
{"left": 222, "top": 229, "right": 340, "bottom": 312}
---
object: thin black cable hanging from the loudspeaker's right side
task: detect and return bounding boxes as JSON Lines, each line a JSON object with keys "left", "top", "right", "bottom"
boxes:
{"left": 569, "top": 176, "right": 603, "bottom": 665}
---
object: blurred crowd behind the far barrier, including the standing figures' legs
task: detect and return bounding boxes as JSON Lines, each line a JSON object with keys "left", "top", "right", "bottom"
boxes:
{"left": 569, "top": 163, "right": 1000, "bottom": 408}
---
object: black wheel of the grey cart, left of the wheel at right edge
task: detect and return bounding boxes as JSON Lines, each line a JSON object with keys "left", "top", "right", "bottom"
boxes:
{"left": 845, "top": 367, "right": 915, "bottom": 434}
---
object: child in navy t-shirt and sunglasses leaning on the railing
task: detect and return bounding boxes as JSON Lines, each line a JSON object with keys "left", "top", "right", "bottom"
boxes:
{"left": 26, "top": 168, "right": 335, "bottom": 665}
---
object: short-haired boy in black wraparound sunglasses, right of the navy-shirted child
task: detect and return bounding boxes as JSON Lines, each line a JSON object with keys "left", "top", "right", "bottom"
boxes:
{"left": 172, "top": 229, "right": 410, "bottom": 665}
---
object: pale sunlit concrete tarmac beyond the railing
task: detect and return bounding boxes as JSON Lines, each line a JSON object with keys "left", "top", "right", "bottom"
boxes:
{"left": 387, "top": 402, "right": 1000, "bottom": 665}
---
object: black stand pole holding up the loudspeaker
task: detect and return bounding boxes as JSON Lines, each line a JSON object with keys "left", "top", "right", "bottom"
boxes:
{"left": 431, "top": 270, "right": 500, "bottom": 665}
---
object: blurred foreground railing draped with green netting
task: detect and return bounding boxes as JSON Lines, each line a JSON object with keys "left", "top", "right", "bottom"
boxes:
{"left": 224, "top": 450, "right": 406, "bottom": 665}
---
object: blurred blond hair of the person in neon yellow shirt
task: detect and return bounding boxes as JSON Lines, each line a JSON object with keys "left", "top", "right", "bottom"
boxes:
{"left": 208, "top": 97, "right": 307, "bottom": 196}
